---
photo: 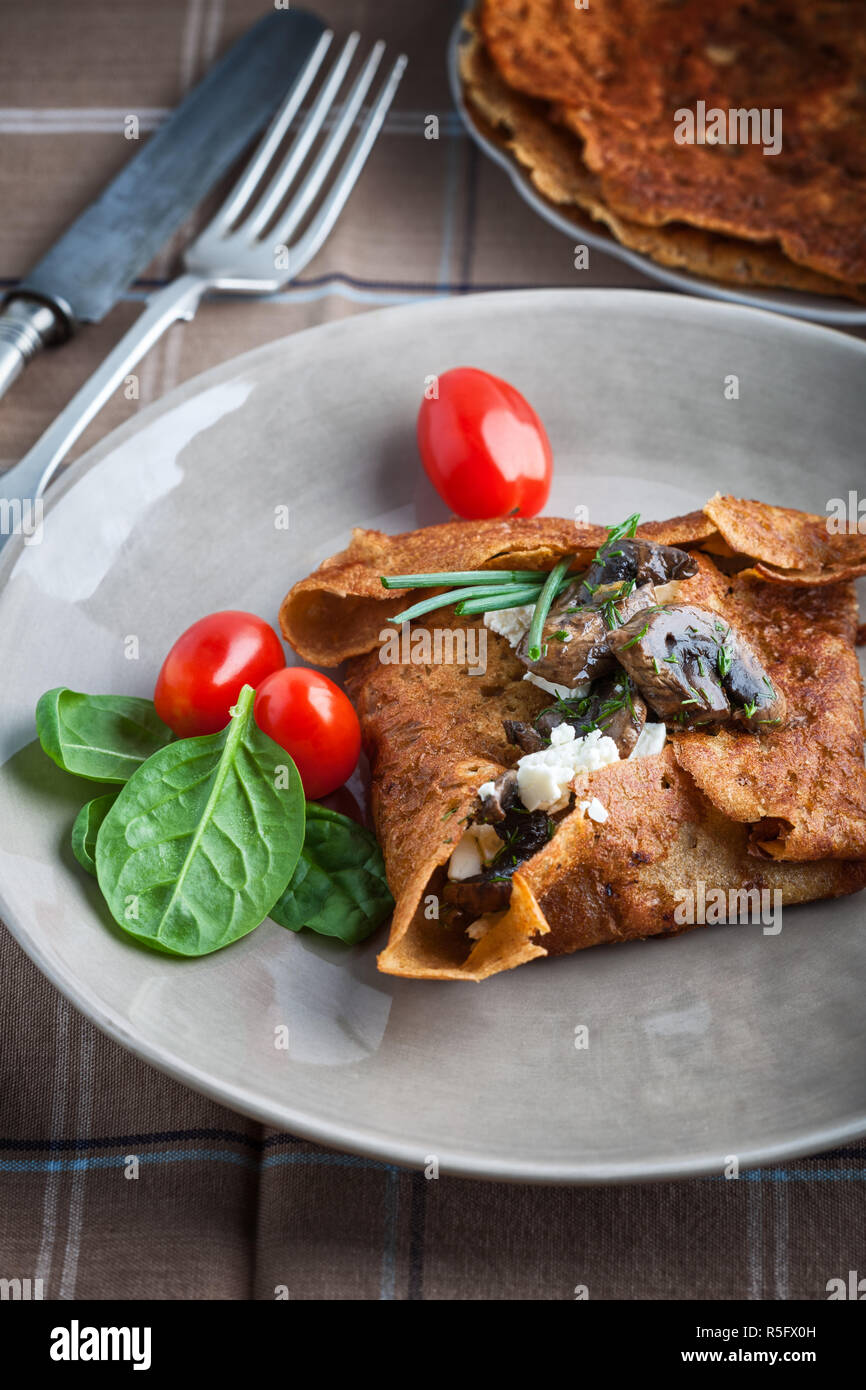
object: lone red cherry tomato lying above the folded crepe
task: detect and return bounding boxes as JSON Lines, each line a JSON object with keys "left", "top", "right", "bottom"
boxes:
{"left": 418, "top": 367, "right": 553, "bottom": 521}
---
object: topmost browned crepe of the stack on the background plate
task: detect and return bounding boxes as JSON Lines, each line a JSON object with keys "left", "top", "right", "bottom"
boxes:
{"left": 481, "top": 0, "right": 866, "bottom": 285}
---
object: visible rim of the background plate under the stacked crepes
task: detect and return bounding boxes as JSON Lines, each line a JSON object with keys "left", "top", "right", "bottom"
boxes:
{"left": 448, "top": 15, "right": 866, "bottom": 328}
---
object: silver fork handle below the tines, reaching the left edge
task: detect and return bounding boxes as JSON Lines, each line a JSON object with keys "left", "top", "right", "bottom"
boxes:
{"left": 0, "top": 274, "right": 209, "bottom": 517}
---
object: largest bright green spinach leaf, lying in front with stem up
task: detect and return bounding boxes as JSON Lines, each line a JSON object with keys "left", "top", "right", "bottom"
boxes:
{"left": 96, "top": 685, "right": 304, "bottom": 956}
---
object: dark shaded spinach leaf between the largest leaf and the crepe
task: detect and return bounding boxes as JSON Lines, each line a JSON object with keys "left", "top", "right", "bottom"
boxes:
{"left": 271, "top": 802, "right": 393, "bottom": 945}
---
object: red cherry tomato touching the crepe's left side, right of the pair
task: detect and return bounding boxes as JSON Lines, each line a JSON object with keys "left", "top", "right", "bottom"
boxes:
{"left": 253, "top": 666, "right": 361, "bottom": 801}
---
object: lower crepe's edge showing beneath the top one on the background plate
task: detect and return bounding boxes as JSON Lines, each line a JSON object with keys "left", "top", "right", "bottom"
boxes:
{"left": 460, "top": 21, "right": 866, "bottom": 297}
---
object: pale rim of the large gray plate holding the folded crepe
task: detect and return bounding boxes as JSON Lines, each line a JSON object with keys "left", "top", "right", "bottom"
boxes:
{"left": 0, "top": 288, "right": 866, "bottom": 1186}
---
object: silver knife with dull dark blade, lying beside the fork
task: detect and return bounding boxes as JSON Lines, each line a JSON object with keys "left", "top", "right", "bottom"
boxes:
{"left": 0, "top": 10, "right": 325, "bottom": 396}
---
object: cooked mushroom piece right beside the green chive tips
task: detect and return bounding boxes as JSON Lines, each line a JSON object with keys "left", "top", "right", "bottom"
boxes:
{"left": 517, "top": 584, "right": 656, "bottom": 689}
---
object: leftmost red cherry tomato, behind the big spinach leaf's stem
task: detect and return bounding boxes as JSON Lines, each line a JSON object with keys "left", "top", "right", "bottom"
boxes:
{"left": 153, "top": 609, "right": 285, "bottom": 738}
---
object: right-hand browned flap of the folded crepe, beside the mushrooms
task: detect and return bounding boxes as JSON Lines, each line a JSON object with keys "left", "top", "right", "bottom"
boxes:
{"left": 671, "top": 544, "right": 866, "bottom": 859}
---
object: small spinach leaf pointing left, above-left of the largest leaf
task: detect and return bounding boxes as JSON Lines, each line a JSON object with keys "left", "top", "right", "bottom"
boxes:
{"left": 36, "top": 685, "right": 174, "bottom": 783}
